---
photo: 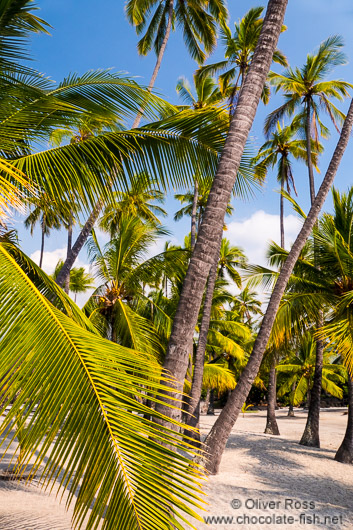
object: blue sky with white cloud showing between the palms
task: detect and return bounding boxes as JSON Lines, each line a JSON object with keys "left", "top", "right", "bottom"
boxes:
{"left": 16, "top": 0, "right": 353, "bottom": 286}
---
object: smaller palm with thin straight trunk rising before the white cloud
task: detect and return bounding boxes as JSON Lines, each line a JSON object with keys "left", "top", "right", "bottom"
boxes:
{"left": 254, "top": 122, "right": 322, "bottom": 248}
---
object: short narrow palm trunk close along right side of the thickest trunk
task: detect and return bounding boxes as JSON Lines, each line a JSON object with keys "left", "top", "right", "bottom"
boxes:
{"left": 186, "top": 259, "right": 218, "bottom": 441}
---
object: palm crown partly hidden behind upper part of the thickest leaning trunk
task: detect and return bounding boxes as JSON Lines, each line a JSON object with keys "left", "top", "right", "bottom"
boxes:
{"left": 196, "top": 7, "right": 288, "bottom": 112}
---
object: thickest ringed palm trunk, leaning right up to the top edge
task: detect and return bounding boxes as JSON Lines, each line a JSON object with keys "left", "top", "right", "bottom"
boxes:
{"left": 156, "top": 0, "right": 288, "bottom": 428}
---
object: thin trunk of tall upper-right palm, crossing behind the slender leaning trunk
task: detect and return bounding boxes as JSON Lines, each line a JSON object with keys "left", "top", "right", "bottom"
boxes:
{"left": 299, "top": 100, "right": 324, "bottom": 447}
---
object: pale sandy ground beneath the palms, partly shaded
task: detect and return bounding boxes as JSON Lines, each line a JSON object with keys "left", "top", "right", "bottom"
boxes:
{"left": 0, "top": 409, "right": 353, "bottom": 530}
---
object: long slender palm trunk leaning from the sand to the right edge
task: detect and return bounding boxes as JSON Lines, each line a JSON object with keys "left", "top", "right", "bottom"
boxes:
{"left": 199, "top": 101, "right": 353, "bottom": 474}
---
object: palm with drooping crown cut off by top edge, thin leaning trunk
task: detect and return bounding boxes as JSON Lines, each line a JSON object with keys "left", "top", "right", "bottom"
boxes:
{"left": 126, "top": 0, "right": 228, "bottom": 128}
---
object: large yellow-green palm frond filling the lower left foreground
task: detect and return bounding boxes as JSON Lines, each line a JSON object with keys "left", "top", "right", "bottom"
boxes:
{"left": 0, "top": 246, "right": 205, "bottom": 530}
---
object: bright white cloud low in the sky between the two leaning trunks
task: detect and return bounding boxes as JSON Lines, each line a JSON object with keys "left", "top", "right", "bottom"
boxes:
{"left": 224, "top": 210, "right": 302, "bottom": 265}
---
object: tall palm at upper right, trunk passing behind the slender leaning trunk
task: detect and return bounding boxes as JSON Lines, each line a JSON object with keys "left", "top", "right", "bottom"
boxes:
{"left": 265, "top": 35, "right": 351, "bottom": 447}
